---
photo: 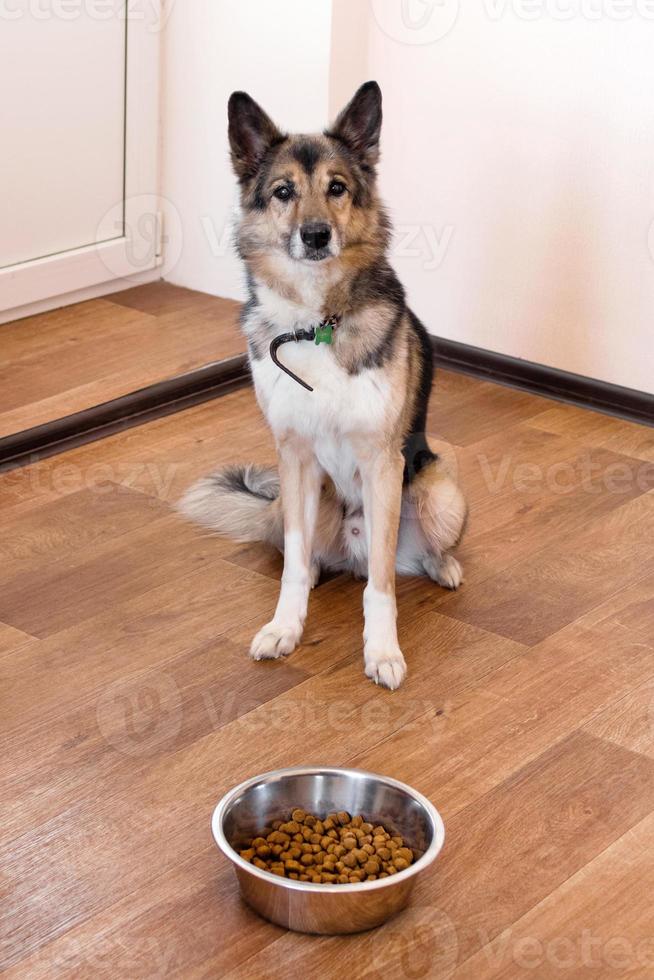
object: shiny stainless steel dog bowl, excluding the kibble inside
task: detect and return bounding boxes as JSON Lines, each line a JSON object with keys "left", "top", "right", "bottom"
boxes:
{"left": 211, "top": 767, "right": 445, "bottom": 935}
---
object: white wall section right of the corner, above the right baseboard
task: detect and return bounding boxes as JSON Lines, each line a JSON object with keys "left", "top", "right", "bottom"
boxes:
{"left": 356, "top": 0, "right": 654, "bottom": 391}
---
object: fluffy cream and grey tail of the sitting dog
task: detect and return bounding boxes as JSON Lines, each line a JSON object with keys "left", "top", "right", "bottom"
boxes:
{"left": 177, "top": 463, "right": 284, "bottom": 548}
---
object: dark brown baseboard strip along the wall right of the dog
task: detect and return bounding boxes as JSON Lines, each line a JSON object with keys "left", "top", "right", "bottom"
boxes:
{"left": 432, "top": 337, "right": 654, "bottom": 425}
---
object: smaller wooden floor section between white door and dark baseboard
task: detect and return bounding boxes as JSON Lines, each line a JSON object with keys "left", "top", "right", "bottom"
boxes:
{"left": 0, "top": 282, "right": 245, "bottom": 438}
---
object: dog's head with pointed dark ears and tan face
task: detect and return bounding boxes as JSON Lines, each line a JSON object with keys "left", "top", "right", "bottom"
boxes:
{"left": 228, "top": 82, "right": 386, "bottom": 265}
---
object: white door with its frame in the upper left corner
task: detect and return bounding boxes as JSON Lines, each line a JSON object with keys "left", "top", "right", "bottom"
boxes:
{"left": 0, "top": 0, "right": 161, "bottom": 318}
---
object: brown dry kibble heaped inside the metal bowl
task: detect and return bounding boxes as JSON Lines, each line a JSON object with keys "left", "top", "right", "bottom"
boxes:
{"left": 239, "top": 809, "right": 414, "bottom": 885}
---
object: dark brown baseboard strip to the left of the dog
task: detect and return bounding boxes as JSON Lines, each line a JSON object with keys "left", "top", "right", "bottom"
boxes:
{"left": 0, "top": 354, "right": 250, "bottom": 472}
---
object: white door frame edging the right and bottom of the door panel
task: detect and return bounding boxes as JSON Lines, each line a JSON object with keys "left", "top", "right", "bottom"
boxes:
{"left": 0, "top": 8, "right": 163, "bottom": 321}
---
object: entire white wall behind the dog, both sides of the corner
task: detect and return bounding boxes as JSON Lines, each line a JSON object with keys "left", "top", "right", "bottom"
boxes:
{"left": 163, "top": 0, "right": 654, "bottom": 391}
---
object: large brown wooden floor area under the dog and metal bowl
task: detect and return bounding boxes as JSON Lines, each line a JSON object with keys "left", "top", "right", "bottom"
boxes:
{"left": 0, "top": 366, "right": 654, "bottom": 980}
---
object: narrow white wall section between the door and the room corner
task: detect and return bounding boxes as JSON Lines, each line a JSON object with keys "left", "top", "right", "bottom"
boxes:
{"left": 162, "top": 0, "right": 331, "bottom": 299}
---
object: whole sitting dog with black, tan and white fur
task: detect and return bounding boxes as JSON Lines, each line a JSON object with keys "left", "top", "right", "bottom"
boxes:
{"left": 181, "top": 81, "right": 466, "bottom": 689}
